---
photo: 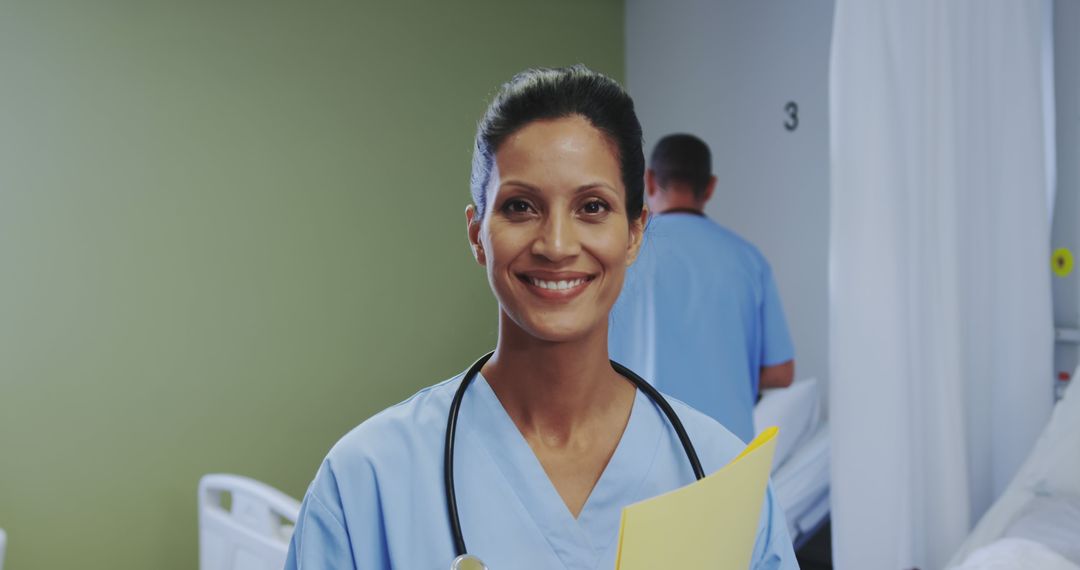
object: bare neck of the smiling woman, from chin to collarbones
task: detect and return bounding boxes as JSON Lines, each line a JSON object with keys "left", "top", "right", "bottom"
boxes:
{"left": 483, "top": 314, "right": 635, "bottom": 446}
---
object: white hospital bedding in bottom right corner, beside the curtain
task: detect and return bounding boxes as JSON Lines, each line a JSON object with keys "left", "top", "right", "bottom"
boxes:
{"left": 949, "top": 369, "right": 1080, "bottom": 570}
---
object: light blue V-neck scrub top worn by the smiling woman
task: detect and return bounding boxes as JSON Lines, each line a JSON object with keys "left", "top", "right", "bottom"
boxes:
{"left": 285, "top": 367, "right": 798, "bottom": 570}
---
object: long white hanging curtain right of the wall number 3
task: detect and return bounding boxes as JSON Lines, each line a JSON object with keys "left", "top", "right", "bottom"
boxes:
{"left": 829, "top": 0, "right": 1053, "bottom": 570}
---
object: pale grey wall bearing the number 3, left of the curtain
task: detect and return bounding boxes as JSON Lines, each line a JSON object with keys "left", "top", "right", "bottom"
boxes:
{"left": 626, "top": 0, "right": 833, "bottom": 381}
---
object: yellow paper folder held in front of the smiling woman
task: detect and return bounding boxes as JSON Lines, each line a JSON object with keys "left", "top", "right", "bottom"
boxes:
{"left": 616, "top": 428, "right": 779, "bottom": 570}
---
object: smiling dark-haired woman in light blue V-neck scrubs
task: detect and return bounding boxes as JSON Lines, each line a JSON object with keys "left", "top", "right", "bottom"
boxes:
{"left": 285, "top": 66, "right": 797, "bottom": 570}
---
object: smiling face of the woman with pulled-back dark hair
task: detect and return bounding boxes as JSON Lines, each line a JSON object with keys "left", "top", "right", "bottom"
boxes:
{"left": 467, "top": 117, "right": 647, "bottom": 342}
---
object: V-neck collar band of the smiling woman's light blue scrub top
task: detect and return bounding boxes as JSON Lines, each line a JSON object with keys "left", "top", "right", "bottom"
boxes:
{"left": 467, "top": 375, "right": 662, "bottom": 569}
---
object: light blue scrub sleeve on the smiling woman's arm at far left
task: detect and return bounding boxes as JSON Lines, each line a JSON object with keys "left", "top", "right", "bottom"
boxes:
{"left": 285, "top": 462, "right": 356, "bottom": 570}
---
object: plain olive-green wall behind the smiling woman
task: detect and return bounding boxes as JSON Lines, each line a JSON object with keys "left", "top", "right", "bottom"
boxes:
{"left": 0, "top": 0, "right": 623, "bottom": 570}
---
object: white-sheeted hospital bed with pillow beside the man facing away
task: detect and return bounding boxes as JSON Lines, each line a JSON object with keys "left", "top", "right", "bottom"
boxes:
{"left": 754, "top": 378, "right": 829, "bottom": 548}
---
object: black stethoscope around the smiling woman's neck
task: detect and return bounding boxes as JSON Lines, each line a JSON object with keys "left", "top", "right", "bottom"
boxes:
{"left": 443, "top": 352, "right": 705, "bottom": 570}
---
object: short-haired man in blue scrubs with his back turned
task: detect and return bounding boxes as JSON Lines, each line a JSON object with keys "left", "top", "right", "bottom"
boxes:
{"left": 610, "top": 134, "right": 795, "bottom": 442}
